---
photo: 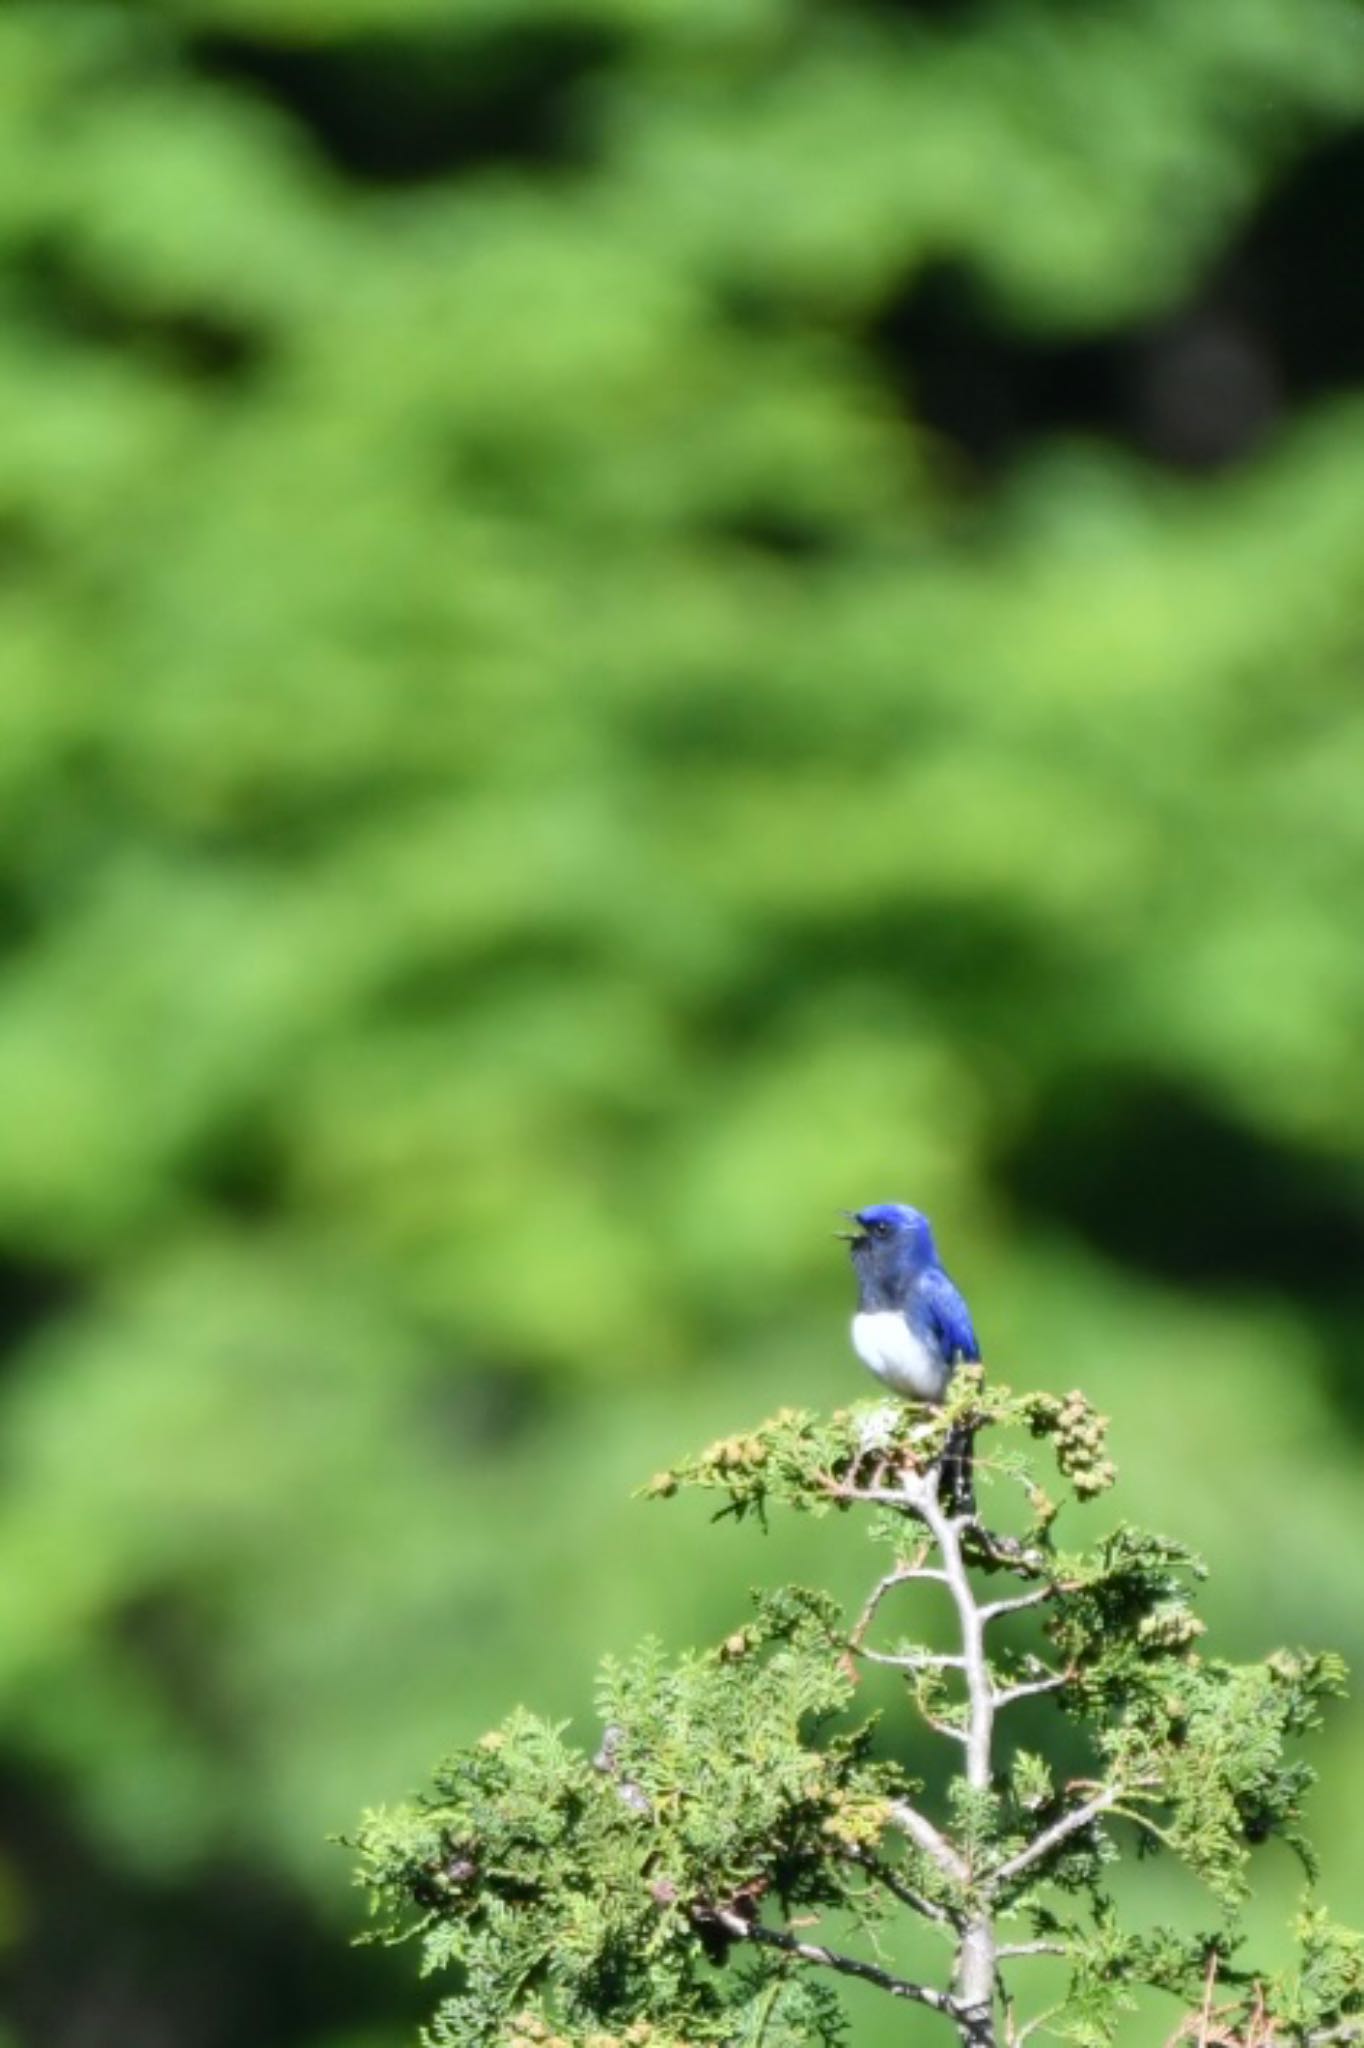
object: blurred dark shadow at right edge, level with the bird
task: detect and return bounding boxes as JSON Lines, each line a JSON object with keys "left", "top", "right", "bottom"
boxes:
{"left": 997, "top": 1069, "right": 1364, "bottom": 1305}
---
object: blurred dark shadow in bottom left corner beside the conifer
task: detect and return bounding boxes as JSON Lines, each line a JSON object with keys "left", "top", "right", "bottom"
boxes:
{"left": 0, "top": 1761, "right": 418, "bottom": 2048}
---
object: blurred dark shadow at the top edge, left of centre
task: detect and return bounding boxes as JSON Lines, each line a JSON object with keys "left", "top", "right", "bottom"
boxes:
{"left": 190, "top": 23, "right": 621, "bottom": 184}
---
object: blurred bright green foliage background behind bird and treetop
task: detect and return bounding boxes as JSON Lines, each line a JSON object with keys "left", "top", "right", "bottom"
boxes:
{"left": 0, "top": 0, "right": 1364, "bottom": 2048}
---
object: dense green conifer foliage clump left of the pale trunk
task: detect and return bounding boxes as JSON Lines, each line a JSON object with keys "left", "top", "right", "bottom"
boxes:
{"left": 360, "top": 1595, "right": 903, "bottom": 2048}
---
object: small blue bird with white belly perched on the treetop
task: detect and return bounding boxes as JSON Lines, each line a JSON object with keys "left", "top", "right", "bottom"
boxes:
{"left": 840, "top": 1202, "right": 981, "bottom": 1513}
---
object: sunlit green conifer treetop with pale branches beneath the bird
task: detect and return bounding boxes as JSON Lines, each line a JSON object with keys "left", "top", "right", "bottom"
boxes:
{"left": 358, "top": 1374, "right": 1364, "bottom": 2048}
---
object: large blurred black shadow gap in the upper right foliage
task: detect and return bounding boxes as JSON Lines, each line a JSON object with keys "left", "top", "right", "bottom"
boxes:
{"left": 870, "top": 131, "right": 1364, "bottom": 481}
